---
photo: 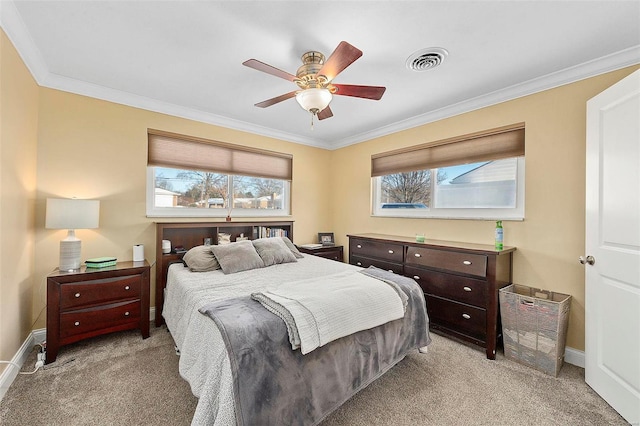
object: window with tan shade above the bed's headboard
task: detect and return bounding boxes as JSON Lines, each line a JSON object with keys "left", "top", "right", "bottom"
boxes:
{"left": 147, "top": 130, "right": 292, "bottom": 217}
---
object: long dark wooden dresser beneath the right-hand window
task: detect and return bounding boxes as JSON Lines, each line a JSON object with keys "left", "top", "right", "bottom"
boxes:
{"left": 348, "top": 234, "right": 515, "bottom": 359}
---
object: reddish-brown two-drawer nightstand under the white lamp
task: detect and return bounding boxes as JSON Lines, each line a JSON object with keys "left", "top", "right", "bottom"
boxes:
{"left": 46, "top": 260, "right": 150, "bottom": 364}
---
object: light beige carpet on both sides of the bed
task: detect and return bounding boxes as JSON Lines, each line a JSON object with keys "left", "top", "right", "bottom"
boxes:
{"left": 0, "top": 325, "right": 627, "bottom": 426}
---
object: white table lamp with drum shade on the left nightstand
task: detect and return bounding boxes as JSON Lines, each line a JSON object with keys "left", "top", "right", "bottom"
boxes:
{"left": 45, "top": 198, "right": 100, "bottom": 271}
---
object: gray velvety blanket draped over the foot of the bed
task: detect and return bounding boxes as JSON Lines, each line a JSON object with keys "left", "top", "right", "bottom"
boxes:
{"left": 200, "top": 268, "right": 430, "bottom": 425}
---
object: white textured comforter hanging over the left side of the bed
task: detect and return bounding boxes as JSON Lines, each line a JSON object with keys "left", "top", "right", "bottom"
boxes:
{"left": 162, "top": 255, "right": 361, "bottom": 426}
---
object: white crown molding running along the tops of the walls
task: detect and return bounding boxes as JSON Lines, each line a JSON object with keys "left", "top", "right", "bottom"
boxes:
{"left": 0, "top": 1, "right": 640, "bottom": 150}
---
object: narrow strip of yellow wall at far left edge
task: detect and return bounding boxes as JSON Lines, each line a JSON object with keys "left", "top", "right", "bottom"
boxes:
{"left": 0, "top": 30, "right": 42, "bottom": 372}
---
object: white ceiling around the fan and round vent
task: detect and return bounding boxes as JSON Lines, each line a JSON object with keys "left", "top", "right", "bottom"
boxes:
{"left": 0, "top": 0, "right": 640, "bottom": 149}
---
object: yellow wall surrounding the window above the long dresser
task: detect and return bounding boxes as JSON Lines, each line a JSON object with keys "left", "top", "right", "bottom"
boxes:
{"left": 331, "top": 67, "right": 637, "bottom": 350}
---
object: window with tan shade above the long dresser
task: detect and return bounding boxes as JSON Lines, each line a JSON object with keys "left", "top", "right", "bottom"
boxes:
{"left": 371, "top": 124, "right": 525, "bottom": 220}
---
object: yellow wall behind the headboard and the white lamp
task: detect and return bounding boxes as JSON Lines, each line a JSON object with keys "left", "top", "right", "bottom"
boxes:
{"left": 34, "top": 88, "right": 331, "bottom": 327}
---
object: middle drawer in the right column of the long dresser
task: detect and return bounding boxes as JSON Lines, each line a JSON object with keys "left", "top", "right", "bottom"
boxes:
{"left": 404, "top": 266, "right": 488, "bottom": 308}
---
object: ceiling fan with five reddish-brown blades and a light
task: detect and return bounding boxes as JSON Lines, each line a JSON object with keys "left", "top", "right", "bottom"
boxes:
{"left": 242, "top": 41, "right": 386, "bottom": 128}
